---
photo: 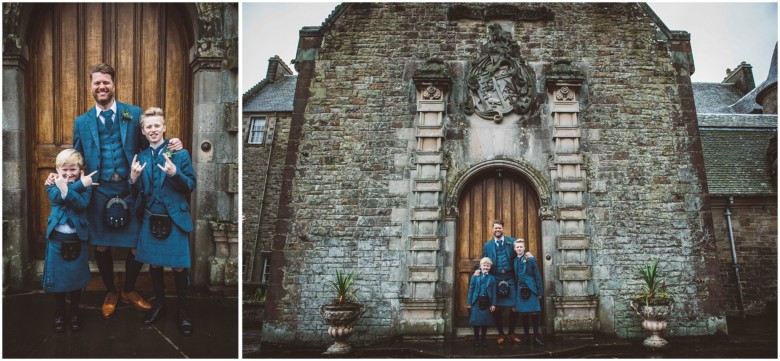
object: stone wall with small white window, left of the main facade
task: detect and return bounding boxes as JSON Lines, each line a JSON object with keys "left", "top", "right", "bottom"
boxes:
{"left": 241, "top": 113, "right": 292, "bottom": 282}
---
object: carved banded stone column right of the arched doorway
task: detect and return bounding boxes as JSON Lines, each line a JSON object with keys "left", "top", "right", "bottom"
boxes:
{"left": 546, "top": 63, "right": 598, "bottom": 333}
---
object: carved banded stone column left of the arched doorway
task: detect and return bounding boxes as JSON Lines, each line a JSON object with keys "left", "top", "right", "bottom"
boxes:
{"left": 400, "top": 61, "right": 452, "bottom": 338}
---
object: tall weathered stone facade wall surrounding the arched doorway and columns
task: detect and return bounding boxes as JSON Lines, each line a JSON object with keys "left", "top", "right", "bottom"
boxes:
{"left": 263, "top": 3, "right": 717, "bottom": 343}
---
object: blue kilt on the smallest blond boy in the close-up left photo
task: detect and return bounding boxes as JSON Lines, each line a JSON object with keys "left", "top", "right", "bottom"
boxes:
{"left": 42, "top": 231, "right": 89, "bottom": 292}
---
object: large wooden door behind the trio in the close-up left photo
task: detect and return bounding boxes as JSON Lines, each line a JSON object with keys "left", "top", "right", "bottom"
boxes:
{"left": 25, "top": 3, "right": 192, "bottom": 260}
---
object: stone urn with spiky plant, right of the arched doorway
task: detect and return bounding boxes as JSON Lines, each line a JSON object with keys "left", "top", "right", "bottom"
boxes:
{"left": 631, "top": 260, "right": 674, "bottom": 348}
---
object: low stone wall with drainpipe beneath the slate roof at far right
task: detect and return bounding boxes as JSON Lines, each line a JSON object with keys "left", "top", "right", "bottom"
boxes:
{"left": 712, "top": 196, "right": 777, "bottom": 315}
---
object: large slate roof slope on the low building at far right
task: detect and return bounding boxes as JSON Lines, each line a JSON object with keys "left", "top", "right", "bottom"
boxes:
{"left": 698, "top": 114, "right": 777, "bottom": 196}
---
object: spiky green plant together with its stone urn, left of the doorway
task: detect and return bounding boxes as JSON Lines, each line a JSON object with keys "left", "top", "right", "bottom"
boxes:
{"left": 320, "top": 270, "right": 365, "bottom": 355}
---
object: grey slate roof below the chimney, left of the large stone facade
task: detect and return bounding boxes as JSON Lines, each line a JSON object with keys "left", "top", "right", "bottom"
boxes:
{"left": 243, "top": 75, "right": 298, "bottom": 112}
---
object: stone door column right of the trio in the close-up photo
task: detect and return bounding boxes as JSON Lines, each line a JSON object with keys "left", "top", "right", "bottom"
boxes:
{"left": 190, "top": 3, "right": 238, "bottom": 294}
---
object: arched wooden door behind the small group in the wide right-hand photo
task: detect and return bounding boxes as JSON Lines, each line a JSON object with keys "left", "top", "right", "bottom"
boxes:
{"left": 455, "top": 169, "right": 542, "bottom": 327}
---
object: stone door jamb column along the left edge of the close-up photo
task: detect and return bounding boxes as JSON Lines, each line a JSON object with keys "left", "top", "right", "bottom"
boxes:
{"left": 3, "top": 4, "right": 32, "bottom": 290}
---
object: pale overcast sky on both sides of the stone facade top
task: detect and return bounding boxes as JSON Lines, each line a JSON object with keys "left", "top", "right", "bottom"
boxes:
{"left": 241, "top": 2, "right": 778, "bottom": 93}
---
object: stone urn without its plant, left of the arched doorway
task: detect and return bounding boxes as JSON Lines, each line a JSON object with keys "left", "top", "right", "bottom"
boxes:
{"left": 320, "top": 302, "right": 365, "bottom": 355}
